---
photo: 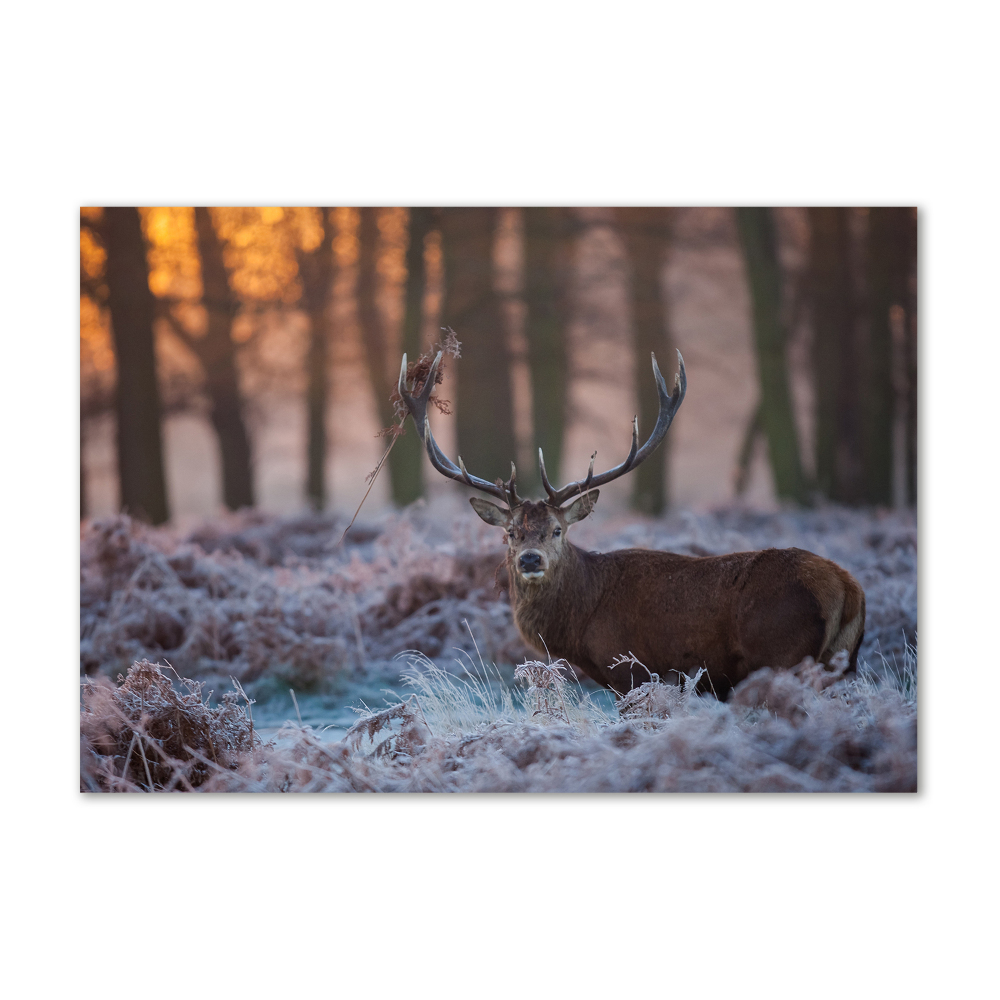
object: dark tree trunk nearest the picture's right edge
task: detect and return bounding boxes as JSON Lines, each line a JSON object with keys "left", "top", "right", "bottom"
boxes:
{"left": 863, "top": 208, "right": 916, "bottom": 506}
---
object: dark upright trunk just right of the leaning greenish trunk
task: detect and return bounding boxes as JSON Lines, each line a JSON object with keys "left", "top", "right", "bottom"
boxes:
{"left": 808, "top": 208, "right": 864, "bottom": 504}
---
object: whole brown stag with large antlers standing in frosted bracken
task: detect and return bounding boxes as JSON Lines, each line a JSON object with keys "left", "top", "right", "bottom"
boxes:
{"left": 397, "top": 351, "right": 865, "bottom": 700}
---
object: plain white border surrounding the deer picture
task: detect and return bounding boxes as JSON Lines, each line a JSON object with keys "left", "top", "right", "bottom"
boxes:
{"left": 0, "top": 0, "right": 1000, "bottom": 997}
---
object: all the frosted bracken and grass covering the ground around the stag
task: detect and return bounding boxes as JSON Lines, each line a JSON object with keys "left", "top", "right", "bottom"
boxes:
{"left": 81, "top": 506, "right": 917, "bottom": 791}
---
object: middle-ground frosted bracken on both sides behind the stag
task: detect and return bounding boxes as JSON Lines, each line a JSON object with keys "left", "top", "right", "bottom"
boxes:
{"left": 80, "top": 507, "right": 917, "bottom": 690}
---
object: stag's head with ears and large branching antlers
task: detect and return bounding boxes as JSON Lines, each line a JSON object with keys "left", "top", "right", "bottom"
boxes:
{"left": 398, "top": 351, "right": 687, "bottom": 586}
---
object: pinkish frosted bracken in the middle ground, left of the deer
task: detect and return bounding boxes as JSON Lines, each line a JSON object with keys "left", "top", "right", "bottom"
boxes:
{"left": 80, "top": 514, "right": 526, "bottom": 690}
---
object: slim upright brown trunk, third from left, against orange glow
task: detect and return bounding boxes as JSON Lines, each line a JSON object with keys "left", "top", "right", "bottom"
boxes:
{"left": 298, "top": 208, "right": 333, "bottom": 511}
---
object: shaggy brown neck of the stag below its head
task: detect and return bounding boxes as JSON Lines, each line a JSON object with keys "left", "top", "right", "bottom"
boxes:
{"left": 510, "top": 544, "right": 604, "bottom": 662}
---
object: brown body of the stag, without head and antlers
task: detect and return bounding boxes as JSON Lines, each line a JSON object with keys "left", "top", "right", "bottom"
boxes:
{"left": 508, "top": 546, "right": 865, "bottom": 699}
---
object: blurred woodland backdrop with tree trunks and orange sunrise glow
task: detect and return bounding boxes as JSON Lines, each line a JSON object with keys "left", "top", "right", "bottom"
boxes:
{"left": 80, "top": 207, "right": 917, "bottom": 523}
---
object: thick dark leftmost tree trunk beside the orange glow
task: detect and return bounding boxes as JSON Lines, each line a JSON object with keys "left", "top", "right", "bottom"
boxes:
{"left": 103, "top": 208, "right": 169, "bottom": 524}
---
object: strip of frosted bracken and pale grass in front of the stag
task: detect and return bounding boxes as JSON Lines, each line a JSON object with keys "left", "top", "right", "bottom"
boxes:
{"left": 81, "top": 660, "right": 917, "bottom": 792}
